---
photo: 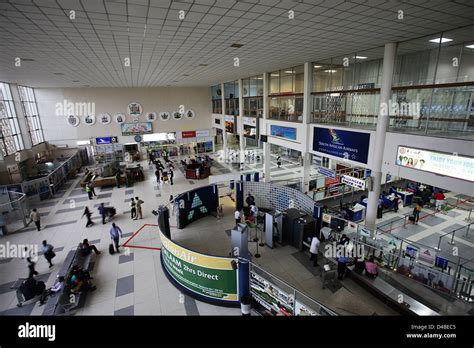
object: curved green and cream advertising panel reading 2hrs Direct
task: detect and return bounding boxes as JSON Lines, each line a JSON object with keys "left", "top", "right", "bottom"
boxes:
{"left": 160, "top": 232, "right": 238, "bottom": 302}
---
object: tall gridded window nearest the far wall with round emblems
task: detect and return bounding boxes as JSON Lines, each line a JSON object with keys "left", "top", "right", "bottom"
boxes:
{"left": 18, "top": 86, "right": 44, "bottom": 146}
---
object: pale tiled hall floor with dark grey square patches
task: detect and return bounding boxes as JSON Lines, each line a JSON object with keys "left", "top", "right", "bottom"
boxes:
{"left": 0, "top": 151, "right": 471, "bottom": 315}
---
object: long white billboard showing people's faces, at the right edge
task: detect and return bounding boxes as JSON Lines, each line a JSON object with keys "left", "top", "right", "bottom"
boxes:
{"left": 396, "top": 146, "right": 474, "bottom": 181}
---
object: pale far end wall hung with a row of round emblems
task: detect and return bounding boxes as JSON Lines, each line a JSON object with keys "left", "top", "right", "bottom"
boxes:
{"left": 35, "top": 87, "right": 213, "bottom": 146}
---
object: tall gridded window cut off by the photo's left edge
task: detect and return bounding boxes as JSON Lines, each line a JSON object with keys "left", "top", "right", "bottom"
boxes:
{"left": 0, "top": 82, "right": 25, "bottom": 156}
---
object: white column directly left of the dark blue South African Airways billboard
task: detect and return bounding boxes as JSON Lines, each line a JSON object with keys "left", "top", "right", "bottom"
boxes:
{"left": 301, "top": 62, "right": 313, "bottom": 192}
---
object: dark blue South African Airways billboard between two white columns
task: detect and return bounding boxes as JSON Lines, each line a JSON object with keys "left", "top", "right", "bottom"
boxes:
{"left": 313, "top": 127, "right": 370, "bottom": 164}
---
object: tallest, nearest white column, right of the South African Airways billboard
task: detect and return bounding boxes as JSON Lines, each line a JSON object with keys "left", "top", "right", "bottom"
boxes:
{"left": 365, "top": 42, "right": 397, "bottom": 231}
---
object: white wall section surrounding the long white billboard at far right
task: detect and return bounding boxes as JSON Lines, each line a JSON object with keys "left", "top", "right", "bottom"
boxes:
{"left": 382, "top": 133, "right": 474, "bottom": 196}
